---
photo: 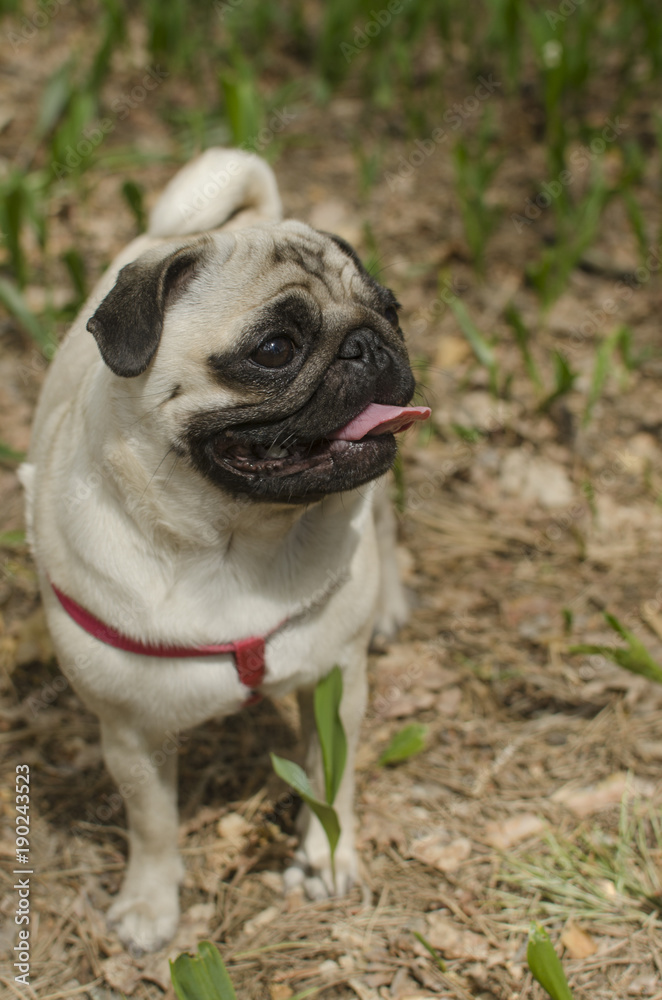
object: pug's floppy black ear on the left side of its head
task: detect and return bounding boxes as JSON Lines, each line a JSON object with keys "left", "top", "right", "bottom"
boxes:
{"left": 87, "top": 243, "right": 206, "bottom": 378}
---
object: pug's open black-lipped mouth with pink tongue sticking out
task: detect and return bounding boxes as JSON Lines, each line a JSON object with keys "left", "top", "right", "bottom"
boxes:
{"left": 213, "top": 403, "right": 430, "bottom": 479}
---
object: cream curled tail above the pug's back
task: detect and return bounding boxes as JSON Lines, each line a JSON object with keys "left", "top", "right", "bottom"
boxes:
{"left": 147, "top": 148, "right": 283, "bottom": 237}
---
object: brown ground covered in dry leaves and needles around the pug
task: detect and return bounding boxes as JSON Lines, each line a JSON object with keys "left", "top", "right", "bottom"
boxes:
{"left": 0, "top": 8, "right": 662, "bottom": 1000}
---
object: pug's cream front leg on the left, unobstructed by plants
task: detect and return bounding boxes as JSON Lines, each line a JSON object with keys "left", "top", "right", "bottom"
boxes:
{"left": 101, "top": 718, "right": 183, "bottom": 953}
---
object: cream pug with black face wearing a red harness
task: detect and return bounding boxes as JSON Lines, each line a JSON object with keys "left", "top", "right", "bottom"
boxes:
{"left": 21, "top": 149, "right": 429, "bottom": 952}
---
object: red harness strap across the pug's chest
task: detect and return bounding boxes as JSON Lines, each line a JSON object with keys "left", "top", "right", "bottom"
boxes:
{"left": 51, "top": 581, "right": 272, "bottom": 688}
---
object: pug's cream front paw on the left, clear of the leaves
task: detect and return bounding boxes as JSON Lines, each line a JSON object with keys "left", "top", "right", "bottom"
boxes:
{"left": 107, "top": 886, "right": 179, "bottom": 957}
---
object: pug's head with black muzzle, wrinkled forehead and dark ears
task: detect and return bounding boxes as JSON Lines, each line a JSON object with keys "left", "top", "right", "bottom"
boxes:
{"left": 88, "top": 222, "right": 414, "bottom": 503}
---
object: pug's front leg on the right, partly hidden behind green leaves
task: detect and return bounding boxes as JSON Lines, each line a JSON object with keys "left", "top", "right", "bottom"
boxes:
{"left": 285, "top": 652, "right": 367, "bottom": 899}
